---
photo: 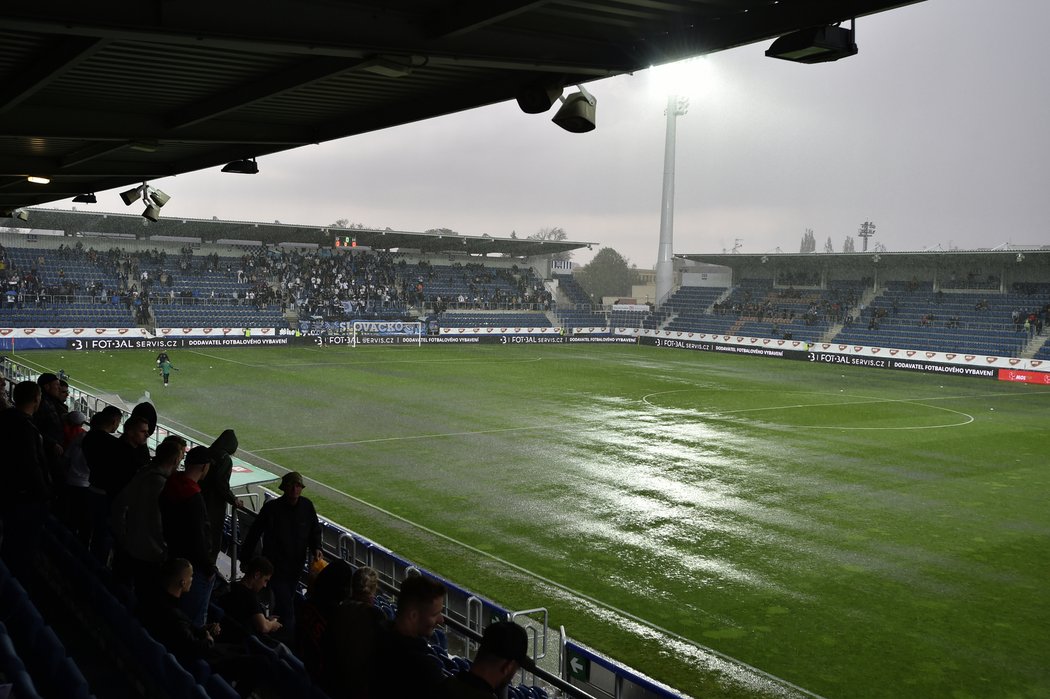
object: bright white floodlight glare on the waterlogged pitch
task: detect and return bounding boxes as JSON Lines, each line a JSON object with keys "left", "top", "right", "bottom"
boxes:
{"left": 557, "top": 401, "right": 831, "bottom": 605}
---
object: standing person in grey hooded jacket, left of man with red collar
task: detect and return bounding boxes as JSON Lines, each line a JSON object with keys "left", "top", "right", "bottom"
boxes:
{"left": 109, "top": 436, "right": 186, "bottom": 594}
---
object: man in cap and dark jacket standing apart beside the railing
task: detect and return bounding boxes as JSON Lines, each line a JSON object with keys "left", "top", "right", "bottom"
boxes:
{"left": 239, "top": 471, "right": 322, "bottom": 638}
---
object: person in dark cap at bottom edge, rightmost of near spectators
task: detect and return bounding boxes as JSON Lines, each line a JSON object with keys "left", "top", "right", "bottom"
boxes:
{"left": 438, "top": 621, "right": 536, "bottom": 699}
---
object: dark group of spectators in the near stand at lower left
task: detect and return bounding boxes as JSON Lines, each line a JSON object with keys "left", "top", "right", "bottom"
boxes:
{"left": 0, "top": 365, "right": 534, "bottom": 699}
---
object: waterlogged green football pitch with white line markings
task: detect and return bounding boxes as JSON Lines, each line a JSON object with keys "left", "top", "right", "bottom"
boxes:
{"left": 18, "top": 345, "right": 1050, "bottom": 698}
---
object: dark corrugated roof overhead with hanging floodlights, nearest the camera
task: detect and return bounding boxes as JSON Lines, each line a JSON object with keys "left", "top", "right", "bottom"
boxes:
{"left": 0, "top": 0, "right": 921, "bottom": 213}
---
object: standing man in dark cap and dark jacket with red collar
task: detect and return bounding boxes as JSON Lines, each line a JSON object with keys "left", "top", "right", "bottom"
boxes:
{"left": 161, "top": 446, "right": 215, "bottom": 627}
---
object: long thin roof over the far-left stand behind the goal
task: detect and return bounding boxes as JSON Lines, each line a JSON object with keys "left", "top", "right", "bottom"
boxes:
{"left": 6, "top": 209, "right": 593, "bottom": 257}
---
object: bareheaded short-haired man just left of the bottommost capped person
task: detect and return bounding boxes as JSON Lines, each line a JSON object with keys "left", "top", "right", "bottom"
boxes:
{"left": 371, "top": 575, "right": 445, "bottom": 699}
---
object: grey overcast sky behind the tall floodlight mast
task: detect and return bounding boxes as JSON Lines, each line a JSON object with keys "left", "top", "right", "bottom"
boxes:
{"left": 55, "top": 0, "right": 1050, "bottom": 268}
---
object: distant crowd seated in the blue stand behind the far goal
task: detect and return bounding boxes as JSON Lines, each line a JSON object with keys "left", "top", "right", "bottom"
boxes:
{"left": 0, "top": 241, "right": 553, "bottom": 324}
